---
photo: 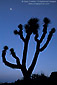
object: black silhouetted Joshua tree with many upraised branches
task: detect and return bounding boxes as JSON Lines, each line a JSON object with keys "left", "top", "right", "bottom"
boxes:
{"left": 2, "top": 18, "right": 55, "bottom": 79}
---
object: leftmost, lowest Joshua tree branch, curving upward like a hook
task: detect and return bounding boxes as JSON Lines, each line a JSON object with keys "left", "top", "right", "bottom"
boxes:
{"left": 2, "top": 46, "right": 21, "bottom": 69}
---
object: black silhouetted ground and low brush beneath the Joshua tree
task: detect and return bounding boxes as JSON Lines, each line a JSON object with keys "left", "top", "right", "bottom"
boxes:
{"left": 0, "top": 72, "right": 57, "bottom": 85}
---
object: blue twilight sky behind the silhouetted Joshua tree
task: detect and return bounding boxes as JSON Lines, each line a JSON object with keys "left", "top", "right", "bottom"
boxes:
{"left": 0, "top": 0, "right": 57, "bottom": 82}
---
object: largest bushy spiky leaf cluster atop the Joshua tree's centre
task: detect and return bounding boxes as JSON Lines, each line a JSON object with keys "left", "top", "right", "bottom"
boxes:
{"left": 25, "top": 18, "right": 39, "bottom": 34}
